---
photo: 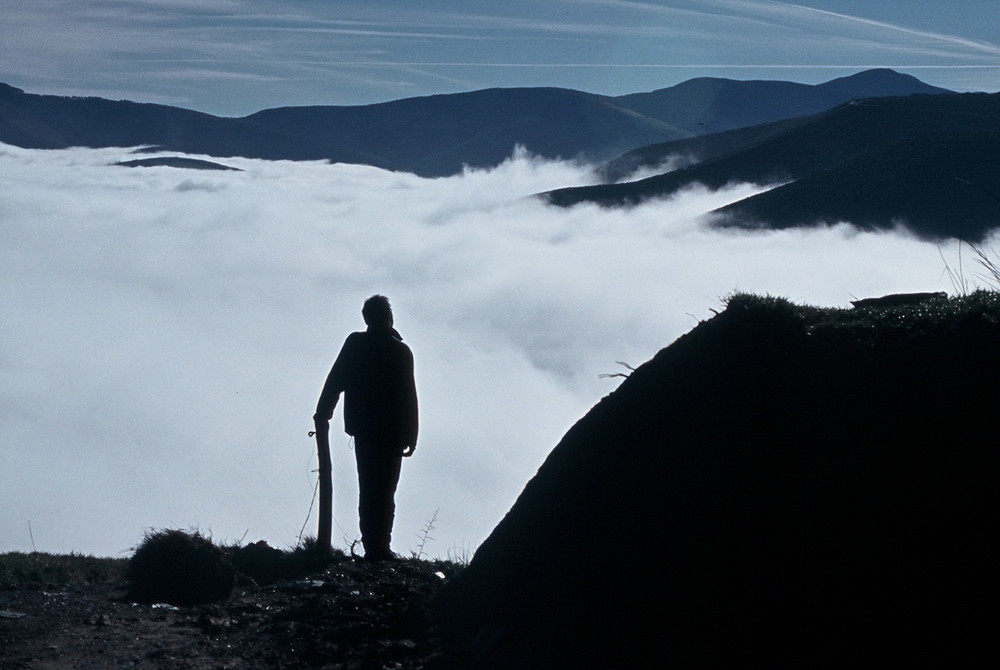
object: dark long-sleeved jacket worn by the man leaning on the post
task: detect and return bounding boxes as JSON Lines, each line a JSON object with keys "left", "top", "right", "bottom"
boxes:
{"left": 316, "top": 327, "right": 417, "bottom": 448}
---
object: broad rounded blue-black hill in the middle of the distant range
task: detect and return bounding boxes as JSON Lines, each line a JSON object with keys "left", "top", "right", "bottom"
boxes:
{"left": 241, "top": 88, "right": 683, "bottom": 176}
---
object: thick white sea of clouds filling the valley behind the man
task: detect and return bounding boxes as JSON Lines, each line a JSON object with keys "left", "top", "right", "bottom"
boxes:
{"left": 0, "top": 145, "right": 984, "bottom": 557}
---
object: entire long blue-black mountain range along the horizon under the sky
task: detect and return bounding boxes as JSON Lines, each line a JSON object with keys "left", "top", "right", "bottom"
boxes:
{"left": 0, "top": 71, "right": 945, "bottom": 177}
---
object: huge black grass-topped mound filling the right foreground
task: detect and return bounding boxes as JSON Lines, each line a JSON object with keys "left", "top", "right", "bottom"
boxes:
{"left": 439, "top": 292, "right": 1000, "bottom": 669}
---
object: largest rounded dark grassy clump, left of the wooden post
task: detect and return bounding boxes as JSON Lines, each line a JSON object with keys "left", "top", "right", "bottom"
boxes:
{"left": 127, "top": 530, "right": 235, "bottom": 606}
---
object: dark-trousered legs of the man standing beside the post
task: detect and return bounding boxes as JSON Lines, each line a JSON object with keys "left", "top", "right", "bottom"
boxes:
{"left": 354, "top": 439, "right": 402, "bottom": 560}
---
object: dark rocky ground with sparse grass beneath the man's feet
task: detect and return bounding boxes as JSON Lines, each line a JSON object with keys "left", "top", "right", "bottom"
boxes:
{"left": 0, "top": 557, "right": 460, "bottom": 670}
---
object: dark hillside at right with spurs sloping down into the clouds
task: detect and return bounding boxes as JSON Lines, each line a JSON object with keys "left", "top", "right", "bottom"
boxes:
{"left": 545, "top": 94, "right": 1000, "bottom": 241}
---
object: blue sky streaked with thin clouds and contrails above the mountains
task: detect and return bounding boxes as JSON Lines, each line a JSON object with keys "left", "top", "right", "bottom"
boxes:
{"left": 0, "top": 0, "right": 1000, "bottom": 115}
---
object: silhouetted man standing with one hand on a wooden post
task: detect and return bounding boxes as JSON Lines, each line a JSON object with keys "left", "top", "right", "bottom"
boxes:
{"left": 313, "top": 295, "right": 417, "bottom": 561}
